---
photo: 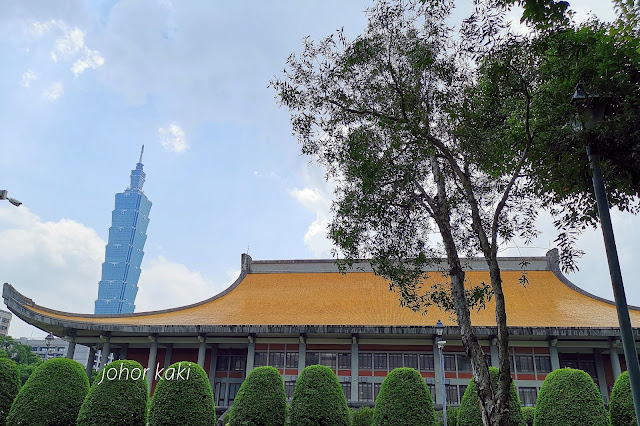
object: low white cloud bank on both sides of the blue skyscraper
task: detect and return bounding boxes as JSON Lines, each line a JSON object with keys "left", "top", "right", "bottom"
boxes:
{"left": 0, "top": 203, "right": 235, "bottom": 337}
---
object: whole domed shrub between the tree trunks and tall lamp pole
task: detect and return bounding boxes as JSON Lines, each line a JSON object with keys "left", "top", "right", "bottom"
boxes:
{"left": 533, "top": 368, "right": 609, "bottom": 426}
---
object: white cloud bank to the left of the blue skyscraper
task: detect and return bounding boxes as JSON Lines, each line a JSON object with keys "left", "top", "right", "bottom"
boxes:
{"left": 0, "top": 205, "right": 105, "bottom": 337}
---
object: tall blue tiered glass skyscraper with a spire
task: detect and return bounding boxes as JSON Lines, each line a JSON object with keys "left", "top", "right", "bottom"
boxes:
{"left": 95, "top": 145, "right": 151, "bottom": 314}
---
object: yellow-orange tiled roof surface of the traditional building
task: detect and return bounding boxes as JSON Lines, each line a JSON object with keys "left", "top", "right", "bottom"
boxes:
{"left": 20, "top": 270, "right": 640, "bottom": 328}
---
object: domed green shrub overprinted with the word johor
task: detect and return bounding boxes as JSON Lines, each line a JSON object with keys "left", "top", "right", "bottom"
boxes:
{"left": 76, "top": 360, "right": 148, "bottom": 426}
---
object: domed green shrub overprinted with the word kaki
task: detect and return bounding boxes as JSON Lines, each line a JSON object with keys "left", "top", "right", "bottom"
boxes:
{"left": 149, "top": 361, "right": 216, "bottom": 426}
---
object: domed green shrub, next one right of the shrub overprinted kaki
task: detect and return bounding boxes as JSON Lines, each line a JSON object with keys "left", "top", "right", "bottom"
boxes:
{"left": 229, "top": 367, "right": 287, "bottom": 426}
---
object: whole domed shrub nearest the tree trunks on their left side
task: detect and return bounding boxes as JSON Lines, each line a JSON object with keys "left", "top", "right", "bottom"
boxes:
{"left": 373, "top": 368, "right": 436, "bottom": 426}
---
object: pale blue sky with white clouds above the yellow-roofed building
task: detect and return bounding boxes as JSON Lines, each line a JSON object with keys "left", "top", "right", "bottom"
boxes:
{"left": 0, "top": 0, "right": 640, "bottom": 337}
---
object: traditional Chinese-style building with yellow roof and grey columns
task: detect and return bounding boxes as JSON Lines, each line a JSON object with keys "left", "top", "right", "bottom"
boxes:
{"left": 3, "top": 250, "right": 640, "bottom": 407}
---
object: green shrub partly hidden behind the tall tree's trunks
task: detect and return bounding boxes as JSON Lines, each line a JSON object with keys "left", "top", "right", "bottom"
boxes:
{"left": 457, "top": 367, "right": 524, "bottom": 426}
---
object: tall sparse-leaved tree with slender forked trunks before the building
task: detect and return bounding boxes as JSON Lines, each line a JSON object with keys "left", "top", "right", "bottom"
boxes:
{"left": 271, "top": 1, "right": 537, "bottom": 425}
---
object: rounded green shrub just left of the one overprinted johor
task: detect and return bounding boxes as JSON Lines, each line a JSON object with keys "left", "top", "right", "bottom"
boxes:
{"left": 7, "top": 358, "right": 89, "bottom": 426}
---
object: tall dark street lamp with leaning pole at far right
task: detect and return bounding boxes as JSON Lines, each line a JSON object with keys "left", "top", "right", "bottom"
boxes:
{"left": 572, "top": 83, "right": 640, "bottom": 419}
